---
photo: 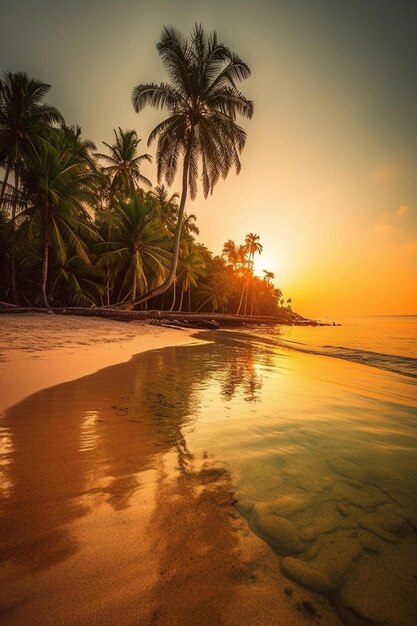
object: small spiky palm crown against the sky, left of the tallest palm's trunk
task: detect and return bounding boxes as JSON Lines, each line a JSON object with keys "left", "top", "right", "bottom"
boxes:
{"left": 95, "top": 126, "right": 152, "bottom": 197}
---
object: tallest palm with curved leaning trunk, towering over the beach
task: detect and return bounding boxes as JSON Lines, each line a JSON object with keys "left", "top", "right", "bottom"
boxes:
{"left": 132, "top": 25, "right": 253, "bottom": 302}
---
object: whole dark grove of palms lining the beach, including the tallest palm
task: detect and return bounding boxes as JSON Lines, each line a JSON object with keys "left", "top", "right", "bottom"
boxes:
{"left": 0, "top": 27, "right": 289, "bottom": 315}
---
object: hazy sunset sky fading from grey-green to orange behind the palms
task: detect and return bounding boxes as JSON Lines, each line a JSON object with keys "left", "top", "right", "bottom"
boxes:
{"left": 0, "top": 0, "right": 417, "bottom": 319}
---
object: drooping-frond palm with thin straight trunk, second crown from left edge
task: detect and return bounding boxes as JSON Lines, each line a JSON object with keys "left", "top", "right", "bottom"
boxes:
{"left": 22, "top": 136, "right": 98, "bottom": 307}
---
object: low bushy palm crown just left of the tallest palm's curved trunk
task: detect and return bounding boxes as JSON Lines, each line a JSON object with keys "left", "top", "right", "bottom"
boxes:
{"left": 95, "top": 190, "right": 170, "bottom": 302}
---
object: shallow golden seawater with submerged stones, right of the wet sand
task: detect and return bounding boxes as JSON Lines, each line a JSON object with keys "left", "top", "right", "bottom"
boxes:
{"left": 182, "top": 317, "right": 417, "bottom": 626}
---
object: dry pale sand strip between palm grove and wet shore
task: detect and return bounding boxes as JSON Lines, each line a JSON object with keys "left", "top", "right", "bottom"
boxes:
{"left": 0, "top": 313, "right": 203, "bottom": 414}
